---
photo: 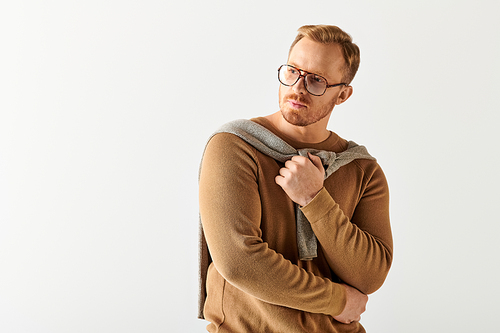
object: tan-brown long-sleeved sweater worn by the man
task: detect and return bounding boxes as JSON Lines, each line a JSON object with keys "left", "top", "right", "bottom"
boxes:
{"left": 200, "top": 118, "right": 392, "bottom": 333}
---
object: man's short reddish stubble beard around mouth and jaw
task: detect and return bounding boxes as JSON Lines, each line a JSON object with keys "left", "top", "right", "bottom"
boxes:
{"left": 280, "top": 93, "right": 336, "bottom": 127}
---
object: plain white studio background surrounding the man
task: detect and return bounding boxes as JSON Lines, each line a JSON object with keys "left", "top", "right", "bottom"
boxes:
{"left": 0, "top": 0, "right": 500, "bottom": 332}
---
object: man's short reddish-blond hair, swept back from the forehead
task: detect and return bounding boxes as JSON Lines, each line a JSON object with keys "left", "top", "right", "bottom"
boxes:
{"left": 289, "top": 25, "right": 360, "bottom": 84}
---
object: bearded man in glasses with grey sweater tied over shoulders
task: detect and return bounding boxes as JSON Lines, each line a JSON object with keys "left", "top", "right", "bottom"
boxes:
{"left": 199, "top": 25, "right": 392, "bottom": 333}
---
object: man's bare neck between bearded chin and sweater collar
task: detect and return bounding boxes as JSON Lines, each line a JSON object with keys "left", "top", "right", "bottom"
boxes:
{"left": 265, "top": 111, "right": 330, "bottom": 143}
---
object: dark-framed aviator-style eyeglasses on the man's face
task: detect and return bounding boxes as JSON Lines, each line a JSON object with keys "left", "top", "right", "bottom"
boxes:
{"left": 278, "top": 65, "right": 348, "bottom": 96}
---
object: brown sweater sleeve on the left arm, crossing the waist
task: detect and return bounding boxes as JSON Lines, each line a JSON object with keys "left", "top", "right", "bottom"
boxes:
{"left": 199, "top": 133, "right": 346, "bottom": 316}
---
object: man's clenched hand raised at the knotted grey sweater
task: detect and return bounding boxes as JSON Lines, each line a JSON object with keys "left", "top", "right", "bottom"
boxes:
{"left": 275, "top": 153, "right": 325, "bottom": 206}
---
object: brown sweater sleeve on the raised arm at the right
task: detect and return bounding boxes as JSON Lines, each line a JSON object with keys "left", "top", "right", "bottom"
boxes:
{"left": 301, "top": 162, "right": 393, "bottom": 294}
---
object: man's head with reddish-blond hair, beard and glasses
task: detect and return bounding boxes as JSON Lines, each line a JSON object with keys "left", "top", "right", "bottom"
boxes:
{"left": 279, "top": 25, "right": 359, "bottom": 128}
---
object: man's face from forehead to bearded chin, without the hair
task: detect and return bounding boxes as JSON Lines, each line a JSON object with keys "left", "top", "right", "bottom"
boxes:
{"left": 279, "top": 37, "right": 350, "bottom": 126}
